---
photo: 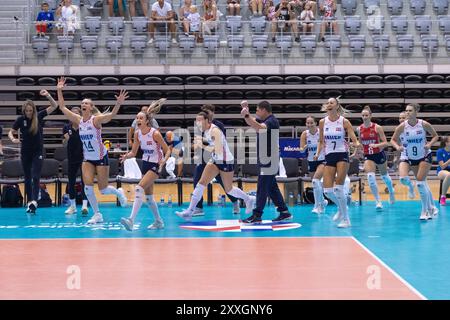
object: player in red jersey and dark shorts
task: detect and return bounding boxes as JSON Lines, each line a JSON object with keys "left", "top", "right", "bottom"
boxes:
{"left": 357, "top": 106, "right": 395, "bottom": 210}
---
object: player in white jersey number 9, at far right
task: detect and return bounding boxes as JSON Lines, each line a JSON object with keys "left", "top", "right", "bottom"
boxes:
{"left": 391, "top": 103, "right": 439, "bottom": 220}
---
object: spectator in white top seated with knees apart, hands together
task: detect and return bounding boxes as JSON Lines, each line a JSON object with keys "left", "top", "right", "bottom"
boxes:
{"left": 148, "top": 0, "right": 177, "bottom": 44}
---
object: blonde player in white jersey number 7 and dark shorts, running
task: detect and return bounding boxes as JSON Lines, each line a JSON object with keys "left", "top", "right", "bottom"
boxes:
{"left": 314, "top": 98, "right": 360, "bottom": 228}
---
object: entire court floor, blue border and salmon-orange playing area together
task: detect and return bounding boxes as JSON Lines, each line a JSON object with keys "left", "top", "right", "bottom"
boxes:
{"left": 0, "top": 201, "right": 450, "bottom": 299}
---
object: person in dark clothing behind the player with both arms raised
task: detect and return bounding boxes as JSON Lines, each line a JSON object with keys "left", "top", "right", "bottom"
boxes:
{"left": 63, "top": 107, "right": 88, "bottom": 215}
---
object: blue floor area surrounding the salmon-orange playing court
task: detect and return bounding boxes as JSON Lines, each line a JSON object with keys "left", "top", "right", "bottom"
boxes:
{"left": 0, "top": 201, "right": 450, "bottom": 299}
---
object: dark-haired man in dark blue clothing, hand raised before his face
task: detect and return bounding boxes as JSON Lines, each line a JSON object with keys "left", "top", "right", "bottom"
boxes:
{"left": 241, "top": 101, "right": 292, "bottom": 223}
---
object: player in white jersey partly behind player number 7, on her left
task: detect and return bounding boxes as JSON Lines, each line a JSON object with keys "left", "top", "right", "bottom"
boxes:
{"left": 300, "top": 116, "right": 328, "bottom": 214}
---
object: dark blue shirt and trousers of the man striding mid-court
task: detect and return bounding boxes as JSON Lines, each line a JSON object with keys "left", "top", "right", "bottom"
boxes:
{"left": 253, "top": 115, "right": 288, "bottom": 217}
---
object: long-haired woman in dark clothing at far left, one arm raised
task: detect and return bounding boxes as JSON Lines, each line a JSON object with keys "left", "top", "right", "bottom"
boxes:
{"left": 8, "top": 90, "right": 58, "bottom": 213}
